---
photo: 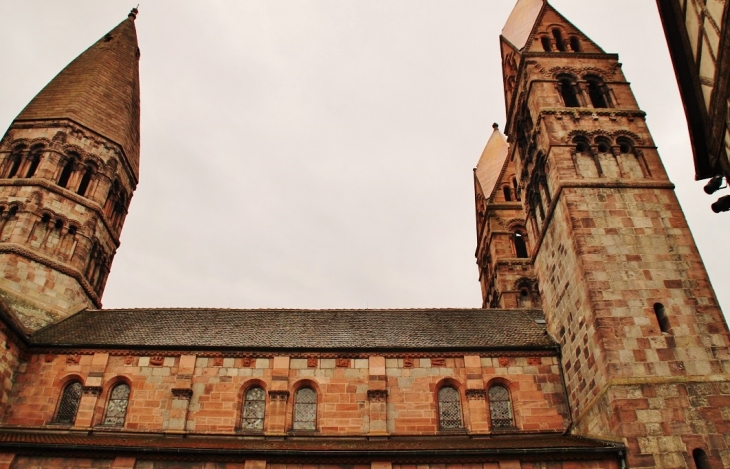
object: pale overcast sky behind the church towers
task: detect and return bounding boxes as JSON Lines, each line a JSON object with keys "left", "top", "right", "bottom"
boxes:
{"left": 0, "top": 0, "right": 730, "bottom": 320}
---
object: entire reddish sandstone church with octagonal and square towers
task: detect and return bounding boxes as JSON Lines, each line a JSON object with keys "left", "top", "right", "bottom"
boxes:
{"left": 0, "top": 0, "right": 730, "bottom": 469}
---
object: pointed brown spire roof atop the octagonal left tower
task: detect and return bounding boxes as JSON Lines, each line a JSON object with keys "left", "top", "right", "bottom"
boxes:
{"left": 15, "top": 10, "right": 139, "bottom": 178}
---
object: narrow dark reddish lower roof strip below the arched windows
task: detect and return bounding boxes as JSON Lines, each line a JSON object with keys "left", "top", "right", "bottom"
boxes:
{"left": 0, "top": 431, "right": 621, "bottom": 458}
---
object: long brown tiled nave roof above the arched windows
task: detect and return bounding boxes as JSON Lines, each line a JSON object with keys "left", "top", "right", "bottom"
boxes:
{"left": 31, "top": 309, "right": 555, "bottom": 350}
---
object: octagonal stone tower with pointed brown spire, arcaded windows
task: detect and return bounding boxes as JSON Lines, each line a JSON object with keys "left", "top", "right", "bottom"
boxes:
{"left": 0, "top": 9, "right": 139, "bottom": 333}
